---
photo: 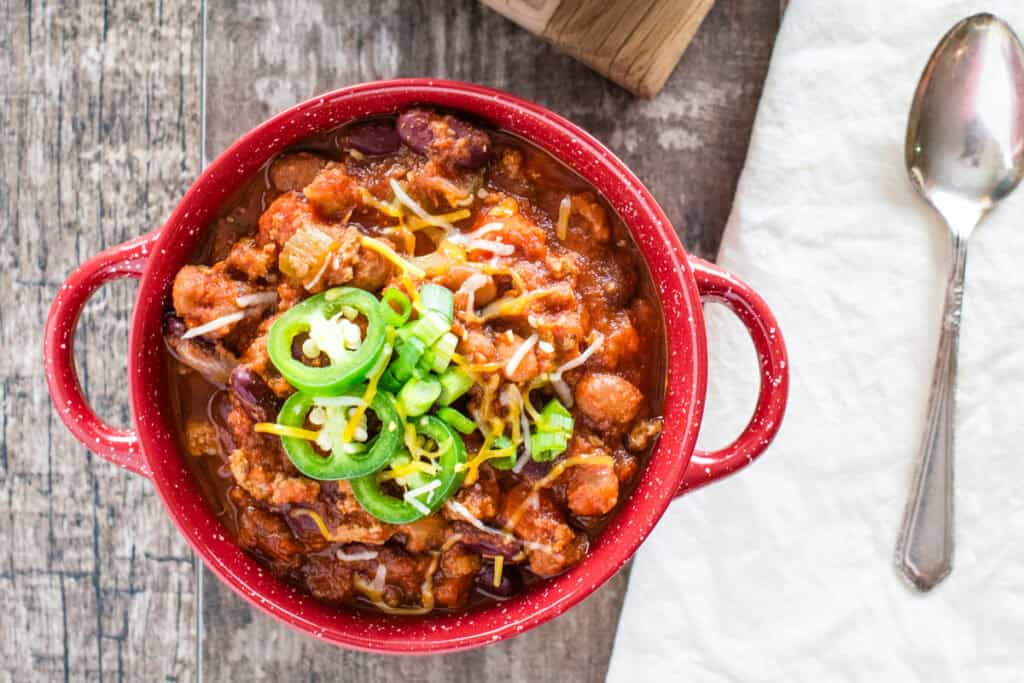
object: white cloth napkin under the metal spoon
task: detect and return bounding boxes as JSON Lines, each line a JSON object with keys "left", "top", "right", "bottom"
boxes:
{"left": 608, "top": 0, "right": 1024, "bottom": 683}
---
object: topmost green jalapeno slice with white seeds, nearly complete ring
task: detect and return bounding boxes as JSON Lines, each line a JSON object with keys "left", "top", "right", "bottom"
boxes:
{"left": 267, "top": 287, "right": 385, "bottom": 396}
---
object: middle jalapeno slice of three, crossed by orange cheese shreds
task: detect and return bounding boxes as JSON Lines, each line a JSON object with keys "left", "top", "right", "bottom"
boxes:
{"left": 278, "top": 387, "right": 402, "bottom": 481}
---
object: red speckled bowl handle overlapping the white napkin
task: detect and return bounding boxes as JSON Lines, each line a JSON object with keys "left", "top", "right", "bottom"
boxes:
{"left": 676, "top": 256, "right": 790, "bottom": 496}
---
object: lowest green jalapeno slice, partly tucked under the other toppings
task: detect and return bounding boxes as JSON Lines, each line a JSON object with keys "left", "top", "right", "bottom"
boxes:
{"left": 351, "top": 415, "right": 466, "bottom": 524}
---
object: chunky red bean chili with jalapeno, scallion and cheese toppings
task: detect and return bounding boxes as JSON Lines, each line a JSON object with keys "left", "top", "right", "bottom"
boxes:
{"left": 165, "top": 108, "right": 665, "bottom": 613}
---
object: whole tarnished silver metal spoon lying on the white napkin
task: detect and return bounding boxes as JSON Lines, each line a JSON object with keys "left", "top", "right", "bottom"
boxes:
{"left": 896, "top": 14, "right": 1024, "bottom": 591}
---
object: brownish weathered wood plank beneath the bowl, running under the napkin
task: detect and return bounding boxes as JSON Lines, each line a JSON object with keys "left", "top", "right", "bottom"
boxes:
{"left": 202, "top": 0, "right": 778, "bottom": 683}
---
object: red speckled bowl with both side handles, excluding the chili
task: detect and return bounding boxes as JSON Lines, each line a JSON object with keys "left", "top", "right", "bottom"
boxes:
{"left": 45, "top": 79, "right": 788, "bottom": 653}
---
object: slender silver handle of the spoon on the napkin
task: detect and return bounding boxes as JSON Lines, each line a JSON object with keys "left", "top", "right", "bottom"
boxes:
{"left": 896, "top": 232, "right": 967, "bottom": 591}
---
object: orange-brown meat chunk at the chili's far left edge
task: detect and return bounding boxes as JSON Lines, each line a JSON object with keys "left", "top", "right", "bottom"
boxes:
{"left": 171, "top": 265, "right": 256, "bottom": 339}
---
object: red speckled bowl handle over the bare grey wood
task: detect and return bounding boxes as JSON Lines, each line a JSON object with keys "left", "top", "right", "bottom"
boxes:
{"left": 43, "top": 231, "right": 157, "bottom": 476}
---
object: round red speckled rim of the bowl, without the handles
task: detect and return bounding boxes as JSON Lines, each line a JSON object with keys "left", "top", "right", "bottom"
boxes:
{"left": 129, "top": 79, "right": 707, "bottom": 653}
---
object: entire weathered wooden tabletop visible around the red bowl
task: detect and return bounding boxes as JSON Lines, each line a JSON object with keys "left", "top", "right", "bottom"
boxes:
{"left": 0, "top": 0, "right": 779, "bottom": 682}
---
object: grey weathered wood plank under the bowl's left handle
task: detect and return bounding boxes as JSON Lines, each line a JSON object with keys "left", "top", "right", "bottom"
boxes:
{"left": 0, "top": 0, "right": 201, "bottom": 681}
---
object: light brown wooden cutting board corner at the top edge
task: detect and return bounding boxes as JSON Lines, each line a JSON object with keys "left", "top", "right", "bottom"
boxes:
{"left": 480, "top": 0, "right": 715, "bottom": 97}
